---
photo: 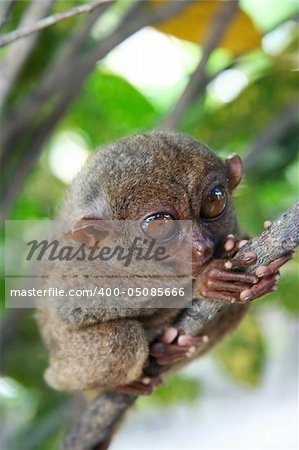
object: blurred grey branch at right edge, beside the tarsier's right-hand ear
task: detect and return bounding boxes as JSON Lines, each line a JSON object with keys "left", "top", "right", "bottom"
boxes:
{"left": 243, "top": 99, "right": 298, "bottom": 170}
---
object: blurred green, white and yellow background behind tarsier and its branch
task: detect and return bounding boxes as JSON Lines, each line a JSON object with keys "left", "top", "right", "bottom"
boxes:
{"left": 0, "top": 0, "right": 299, "bottom": 450}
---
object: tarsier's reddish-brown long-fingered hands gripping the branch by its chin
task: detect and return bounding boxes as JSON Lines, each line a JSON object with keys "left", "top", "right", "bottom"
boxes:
{"left": 195, "top": 227, "right": 293, "bottom": 303}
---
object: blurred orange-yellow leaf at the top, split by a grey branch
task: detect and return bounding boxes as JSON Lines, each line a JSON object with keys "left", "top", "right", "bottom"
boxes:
{"left": 151, "top": 0, "right": 261, "bottom": 55}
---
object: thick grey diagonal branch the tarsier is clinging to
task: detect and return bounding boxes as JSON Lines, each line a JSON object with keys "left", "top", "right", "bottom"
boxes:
{"left": 62, "top": 202, "right": 299, "bottom": 450}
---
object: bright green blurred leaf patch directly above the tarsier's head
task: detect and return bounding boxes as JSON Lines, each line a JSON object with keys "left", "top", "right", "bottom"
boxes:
{"left": 62, "top": 70, "right": 157, "bottom": 148}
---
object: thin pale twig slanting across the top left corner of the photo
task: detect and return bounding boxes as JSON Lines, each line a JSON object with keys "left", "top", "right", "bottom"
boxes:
{"left": 0, "top": 0, "right": 112, "bottom": 48}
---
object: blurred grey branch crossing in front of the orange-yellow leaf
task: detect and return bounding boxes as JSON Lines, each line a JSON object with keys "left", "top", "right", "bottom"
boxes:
{"left": 161, "top": 0, "right": 239, "bottom": 128}
